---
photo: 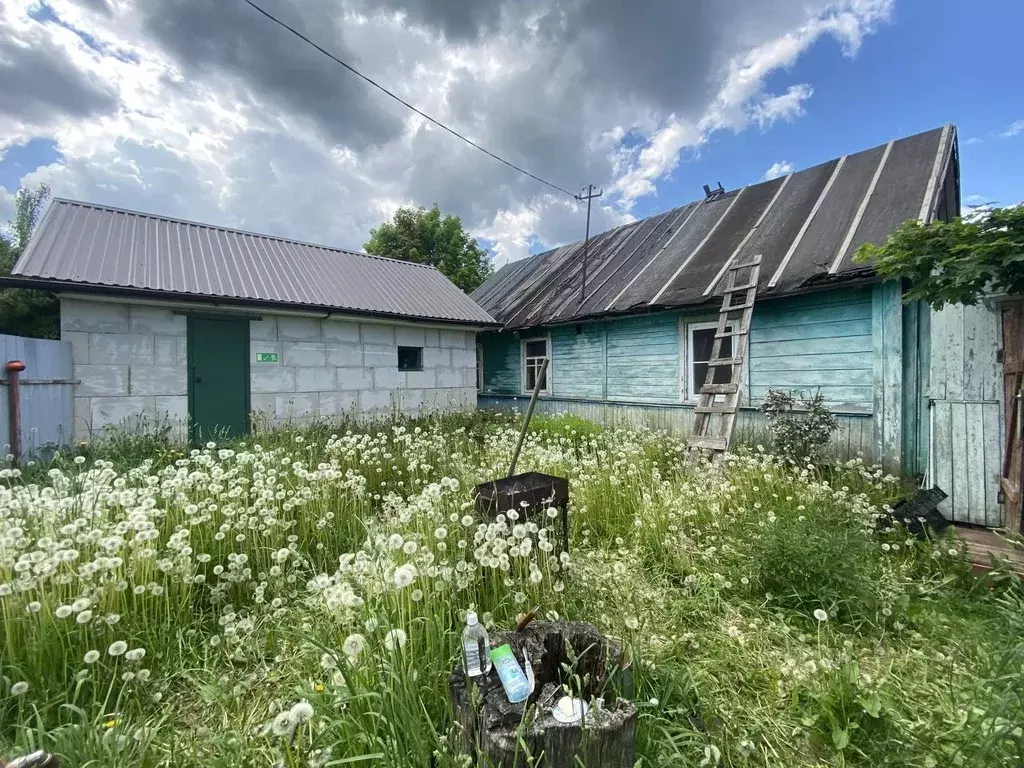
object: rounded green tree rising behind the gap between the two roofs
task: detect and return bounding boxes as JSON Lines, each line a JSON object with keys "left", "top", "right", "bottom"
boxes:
{"left": 362, "top": 204, "right": 494, "bottom": 293}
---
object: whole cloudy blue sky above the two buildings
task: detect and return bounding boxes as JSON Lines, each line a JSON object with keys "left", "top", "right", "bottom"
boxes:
{"left": 0, "top": 0, "right": 1024, "bottom": 265}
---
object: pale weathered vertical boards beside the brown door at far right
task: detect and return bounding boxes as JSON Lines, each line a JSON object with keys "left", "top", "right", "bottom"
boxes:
{"left": 928, "top": 302, "right": 1005, "bottom": 527}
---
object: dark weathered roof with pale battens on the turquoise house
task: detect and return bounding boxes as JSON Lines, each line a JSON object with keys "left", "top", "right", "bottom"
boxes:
{"left": 472, "top": 125, "right": 958, "bottom": 329}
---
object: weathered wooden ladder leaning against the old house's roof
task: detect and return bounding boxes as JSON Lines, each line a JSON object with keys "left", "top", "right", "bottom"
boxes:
{"left": 687, "top": 254, "right": 761, "bottom": 459}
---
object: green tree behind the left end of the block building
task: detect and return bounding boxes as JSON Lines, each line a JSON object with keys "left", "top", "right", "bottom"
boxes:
{"left": 0, "top": 184, "right": 60, "bottom": 339}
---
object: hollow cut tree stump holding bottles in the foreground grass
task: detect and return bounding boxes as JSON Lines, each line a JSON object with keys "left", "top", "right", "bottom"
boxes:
{"left": 450, "top": 622, "right": 637, "bottom": 768}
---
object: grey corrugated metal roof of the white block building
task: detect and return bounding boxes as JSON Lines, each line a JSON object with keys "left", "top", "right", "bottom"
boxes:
{"left": 11, "top": 199, "right": 495, "bottom": 325}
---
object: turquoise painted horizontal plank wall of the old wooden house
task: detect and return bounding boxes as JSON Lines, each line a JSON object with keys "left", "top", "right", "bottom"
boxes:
{"left": 479, "top": 287, "right": 880, "bottom": 414}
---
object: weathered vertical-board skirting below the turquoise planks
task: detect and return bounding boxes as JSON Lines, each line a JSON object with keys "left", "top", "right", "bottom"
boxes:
{"left": 477, "top": 395, "right": 876, "bottom": 463}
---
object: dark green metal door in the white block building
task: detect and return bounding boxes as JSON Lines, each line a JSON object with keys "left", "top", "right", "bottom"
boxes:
{"left": 188, "top": 316, "right": 249, "bottom": 442}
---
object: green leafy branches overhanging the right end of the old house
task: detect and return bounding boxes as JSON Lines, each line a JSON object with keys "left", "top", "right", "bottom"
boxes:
{"left": 855, "top": 206, "right": 1024, "bottom": 309}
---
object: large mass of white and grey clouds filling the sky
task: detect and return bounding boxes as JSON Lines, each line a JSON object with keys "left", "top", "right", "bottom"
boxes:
{"left": 0, "top": 0, "right": 892, "bottom": 263}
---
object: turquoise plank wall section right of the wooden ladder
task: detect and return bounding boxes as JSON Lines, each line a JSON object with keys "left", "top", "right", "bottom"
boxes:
{"left": 749, "top": 288, "right": 873, "bottom": 414}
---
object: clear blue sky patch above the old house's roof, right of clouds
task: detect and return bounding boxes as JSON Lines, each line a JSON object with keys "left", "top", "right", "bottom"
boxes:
{"left": 637, "top": 0, "right": 1024, "bottom": 222}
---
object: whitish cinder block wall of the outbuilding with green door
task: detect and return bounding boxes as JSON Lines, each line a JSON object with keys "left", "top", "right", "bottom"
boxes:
{"left": 60, "top": 298, "right": 476, "bottom": 439}
